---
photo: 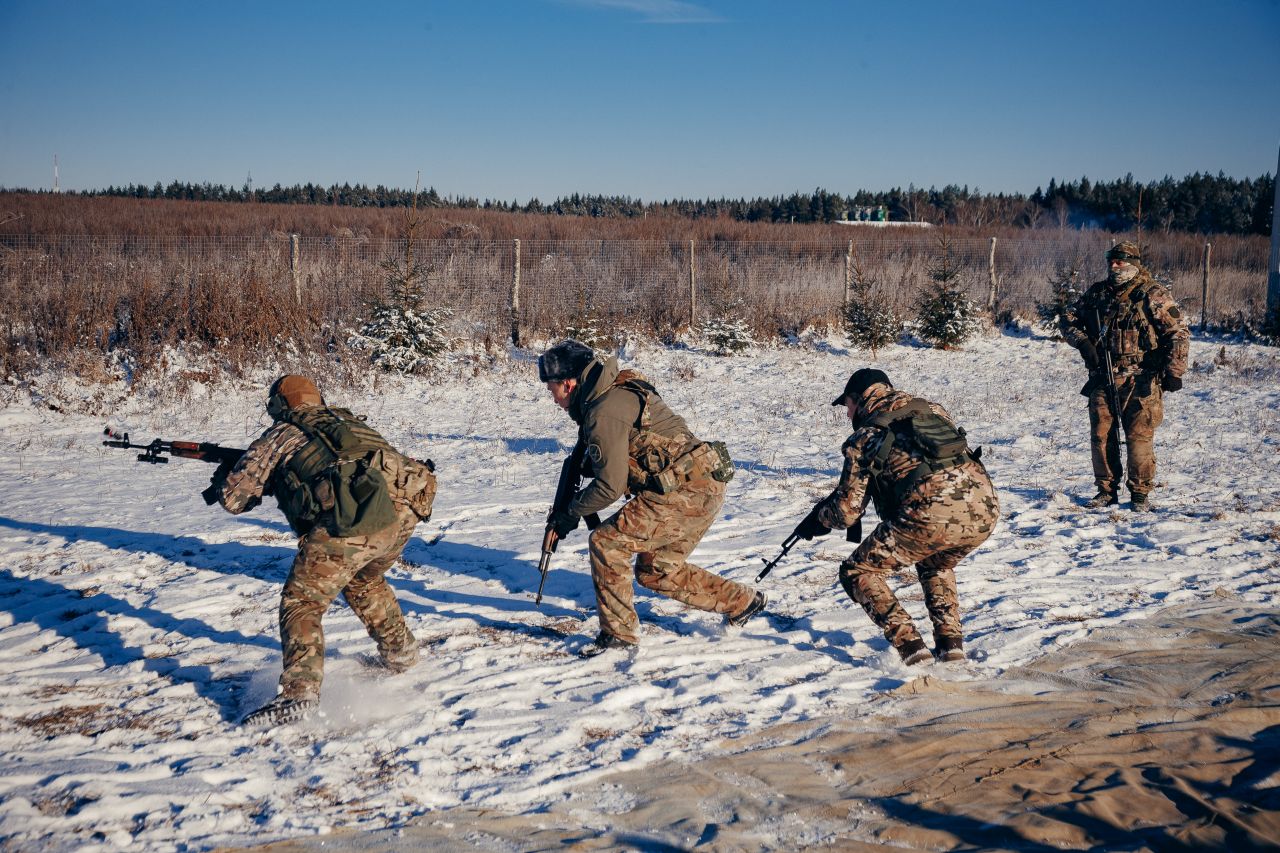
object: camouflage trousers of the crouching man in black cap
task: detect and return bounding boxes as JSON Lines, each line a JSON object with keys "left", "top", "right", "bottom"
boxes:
{"left": 840, "top": 462, "right": 1000, "bottom": 647}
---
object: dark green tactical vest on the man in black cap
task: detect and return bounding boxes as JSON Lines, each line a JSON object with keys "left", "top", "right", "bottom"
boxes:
{"left": 861, "top": 397, "right": 977, "bottom": 520}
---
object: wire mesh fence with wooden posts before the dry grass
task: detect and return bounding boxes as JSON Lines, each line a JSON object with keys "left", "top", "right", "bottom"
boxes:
{"left": 0, "top": 227, "right": 1267, "bottom": 371}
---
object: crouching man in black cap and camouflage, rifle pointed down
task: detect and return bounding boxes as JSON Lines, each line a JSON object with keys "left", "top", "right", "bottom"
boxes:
{"left": 796, "top": 368, "right": 1000, "bottom": 665}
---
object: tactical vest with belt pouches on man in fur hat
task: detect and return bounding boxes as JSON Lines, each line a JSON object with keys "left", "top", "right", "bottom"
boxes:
{"left": 599, "top": 370, "right": 733, "bottom": 494}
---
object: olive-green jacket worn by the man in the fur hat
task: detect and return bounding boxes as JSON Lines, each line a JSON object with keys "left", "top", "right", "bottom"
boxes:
{"left": 568, "top": 356, "right": 699, "bottom": 516}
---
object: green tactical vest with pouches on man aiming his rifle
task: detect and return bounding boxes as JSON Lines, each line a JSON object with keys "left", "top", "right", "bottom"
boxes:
{"left": 275, "top": 406, "right": 397, "bottom": 537}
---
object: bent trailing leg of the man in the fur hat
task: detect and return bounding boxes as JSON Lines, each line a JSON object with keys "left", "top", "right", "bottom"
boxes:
{"left": 635, "top": 483, "right": 755, "bottom": 615}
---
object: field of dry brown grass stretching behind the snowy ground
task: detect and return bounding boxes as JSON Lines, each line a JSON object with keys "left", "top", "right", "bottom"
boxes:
{"left": 0, "top": 192, "right": 1268, "bottom": 380}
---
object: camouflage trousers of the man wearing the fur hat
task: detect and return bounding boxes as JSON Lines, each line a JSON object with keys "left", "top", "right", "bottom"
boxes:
{"left": 590, "top": 478, "right": 755, "bottom": 643}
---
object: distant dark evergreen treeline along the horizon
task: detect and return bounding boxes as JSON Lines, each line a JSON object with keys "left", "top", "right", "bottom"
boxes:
{"left": 40, "top": 173, "right": 1275, "bottom": 234}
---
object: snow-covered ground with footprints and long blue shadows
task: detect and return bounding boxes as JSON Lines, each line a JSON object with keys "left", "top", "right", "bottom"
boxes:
{"left": 0, "top": 334, "right": 1280, "bottom": 850}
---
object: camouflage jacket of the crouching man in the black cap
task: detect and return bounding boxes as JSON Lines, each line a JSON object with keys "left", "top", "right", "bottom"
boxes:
{"left": 818, "top": 386, "right": 987, "bottom": 529}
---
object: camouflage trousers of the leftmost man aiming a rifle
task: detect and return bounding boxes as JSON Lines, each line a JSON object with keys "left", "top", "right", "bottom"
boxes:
{"left": 280, "top": 508, "right": 417, "bottom": 698}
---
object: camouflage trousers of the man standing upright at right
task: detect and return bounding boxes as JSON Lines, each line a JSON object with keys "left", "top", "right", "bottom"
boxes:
{"left": 1089, "top": 374, "right": 1165, "bottom": 494}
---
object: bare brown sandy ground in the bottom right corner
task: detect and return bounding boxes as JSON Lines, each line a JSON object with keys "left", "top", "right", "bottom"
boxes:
{"left": 241, "top": 598, "right": 1280, "bottom": 853}
